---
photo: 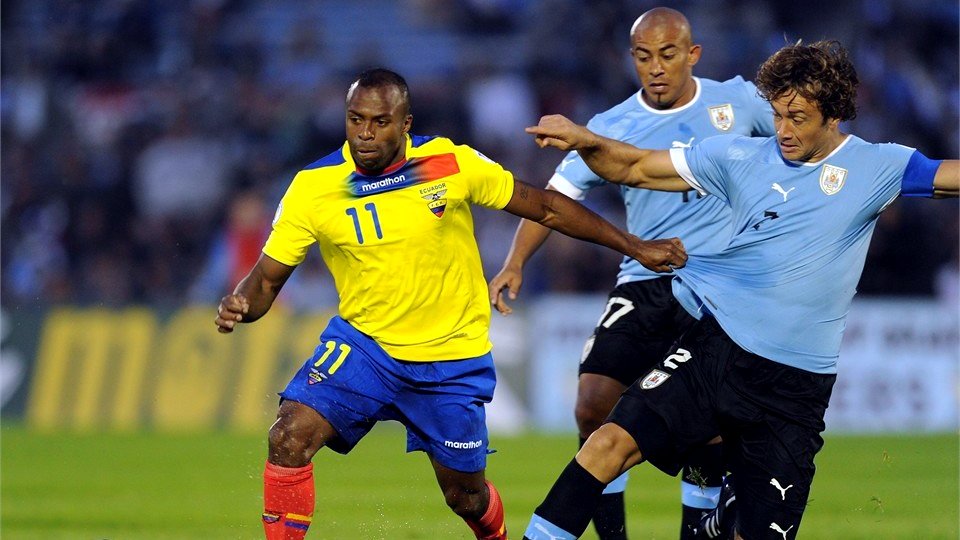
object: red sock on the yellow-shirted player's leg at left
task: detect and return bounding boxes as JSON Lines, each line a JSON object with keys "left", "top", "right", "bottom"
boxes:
{"left": 263, "top": 461, "right": 314, "bottom": 540}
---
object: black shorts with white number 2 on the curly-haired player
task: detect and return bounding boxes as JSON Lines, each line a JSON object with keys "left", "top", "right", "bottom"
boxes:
{"left": 608, "top": 317, "right": 836, "bottom": 540}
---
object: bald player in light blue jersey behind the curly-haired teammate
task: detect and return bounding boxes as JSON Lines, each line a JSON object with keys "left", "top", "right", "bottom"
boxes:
{"left": 490, "top": 7, "right": 774, "bottom": 540}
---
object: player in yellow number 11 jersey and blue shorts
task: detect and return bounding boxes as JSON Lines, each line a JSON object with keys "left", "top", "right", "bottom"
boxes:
{"left": 216, "top": 69, "right": 686, "bottom": 540}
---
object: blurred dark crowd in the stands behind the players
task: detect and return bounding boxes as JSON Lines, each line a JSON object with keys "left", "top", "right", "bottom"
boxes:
{"left": 0, "top": 0, "right": 960, "bottom": 310}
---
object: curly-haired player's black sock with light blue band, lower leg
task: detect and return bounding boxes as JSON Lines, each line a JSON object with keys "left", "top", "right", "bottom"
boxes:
{"left": 523, "top": 459, "right": 605, "bottom": 540}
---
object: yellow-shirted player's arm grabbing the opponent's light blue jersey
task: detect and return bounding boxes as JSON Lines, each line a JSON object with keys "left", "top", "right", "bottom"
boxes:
{"left": 491, "top": 180, "right": 687, "bottom": 278}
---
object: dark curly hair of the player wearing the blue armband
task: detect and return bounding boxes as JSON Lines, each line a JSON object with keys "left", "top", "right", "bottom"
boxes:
{"left": 756, "top": 41, "right": 860, "bottom": 120}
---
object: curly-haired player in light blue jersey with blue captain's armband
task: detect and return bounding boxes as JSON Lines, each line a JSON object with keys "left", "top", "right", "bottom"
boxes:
{"left": 526, "top": 42, "right": 960, "bottom": 540}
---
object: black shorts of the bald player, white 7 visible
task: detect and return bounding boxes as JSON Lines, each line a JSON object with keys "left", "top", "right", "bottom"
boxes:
{"left": 580, "top": 277, "right": 696, "bottom": 386}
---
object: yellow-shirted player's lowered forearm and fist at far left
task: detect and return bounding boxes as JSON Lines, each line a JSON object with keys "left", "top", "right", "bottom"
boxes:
{"left": 216, "top": 254, "right": 296, "bottom": 334}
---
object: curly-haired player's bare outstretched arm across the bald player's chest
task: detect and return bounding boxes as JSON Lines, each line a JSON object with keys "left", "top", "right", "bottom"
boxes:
{"left": 526, "top": 114, "right": 690, "bottom": 191}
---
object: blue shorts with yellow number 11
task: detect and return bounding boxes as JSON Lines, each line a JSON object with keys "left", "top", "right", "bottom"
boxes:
{"left": 280, "top": 317, "right": 497, "bottom": 473}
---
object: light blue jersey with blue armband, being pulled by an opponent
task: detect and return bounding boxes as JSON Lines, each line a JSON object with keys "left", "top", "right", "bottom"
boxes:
{"left": 670, "top": 135, "right": 938, "bottom": 373}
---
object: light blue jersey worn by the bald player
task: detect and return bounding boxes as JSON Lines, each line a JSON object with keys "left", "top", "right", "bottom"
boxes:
{"left": 550, "top": 76, "right": 774, "bottom": 285}
